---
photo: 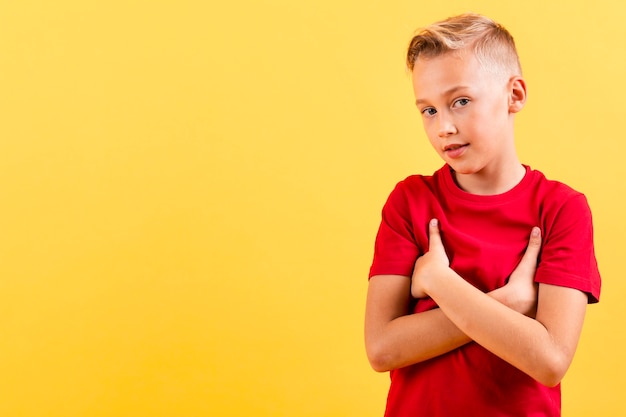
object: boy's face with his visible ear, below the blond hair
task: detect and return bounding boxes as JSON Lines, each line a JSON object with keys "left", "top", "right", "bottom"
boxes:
{"left": 413, "top": 52, "right": 525, "bottom": 175}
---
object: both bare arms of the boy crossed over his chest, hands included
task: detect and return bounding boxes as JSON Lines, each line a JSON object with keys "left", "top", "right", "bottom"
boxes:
{"left": 365, "top": 221, "right": 587, "bottom": 386}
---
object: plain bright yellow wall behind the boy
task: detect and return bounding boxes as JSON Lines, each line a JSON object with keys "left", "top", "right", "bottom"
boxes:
{"left": 0, "top": 0, "right": 626, "bottom": 417}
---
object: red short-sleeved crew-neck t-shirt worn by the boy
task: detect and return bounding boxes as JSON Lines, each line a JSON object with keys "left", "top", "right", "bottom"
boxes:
{"left": 370, "top": 165, "right": 600, "bottom": 417}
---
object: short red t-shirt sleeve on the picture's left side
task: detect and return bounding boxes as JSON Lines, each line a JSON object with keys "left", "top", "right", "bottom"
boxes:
{"left": 369, "top": 182, "right": 421, "bottom": 278}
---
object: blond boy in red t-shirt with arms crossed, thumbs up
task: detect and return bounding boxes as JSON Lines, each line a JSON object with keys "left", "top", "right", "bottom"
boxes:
{"left": 365, "top": 14, "right": 600, "bottom": 417}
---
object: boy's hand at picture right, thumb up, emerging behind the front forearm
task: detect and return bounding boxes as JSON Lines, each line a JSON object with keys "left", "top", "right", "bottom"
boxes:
{"left": 500, "top": 227, "right": 541, "bottom": 318}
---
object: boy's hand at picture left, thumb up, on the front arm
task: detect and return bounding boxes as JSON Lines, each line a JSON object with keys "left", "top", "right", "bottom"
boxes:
{"left": 411, "top": 219, "right": 450, "bottom": 298}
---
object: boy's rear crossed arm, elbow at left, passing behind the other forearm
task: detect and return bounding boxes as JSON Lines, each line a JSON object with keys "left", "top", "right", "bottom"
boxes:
{"left": 365, "top": 224, "right": 541, "bottom": 372}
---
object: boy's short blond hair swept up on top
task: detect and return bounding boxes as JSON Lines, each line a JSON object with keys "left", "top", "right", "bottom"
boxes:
{"left": 406, "top": 13, "right": 522, "bottom": 76}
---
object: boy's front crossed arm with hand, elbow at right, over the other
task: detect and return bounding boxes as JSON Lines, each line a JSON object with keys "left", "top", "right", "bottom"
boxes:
{"left": 413, "top": 219, "right": 587, "bottom": 386}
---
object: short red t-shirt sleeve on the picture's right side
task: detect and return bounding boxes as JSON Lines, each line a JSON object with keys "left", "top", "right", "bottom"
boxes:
{"left": 535, "top": 193, "right": 601, "bottom": 303}
